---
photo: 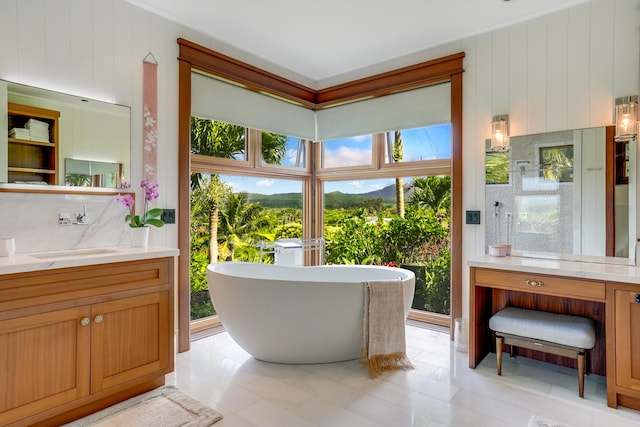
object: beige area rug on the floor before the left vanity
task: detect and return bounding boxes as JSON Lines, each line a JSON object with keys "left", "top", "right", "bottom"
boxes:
{"left": 65, "top": 386, "right": 222, "bottom": 427}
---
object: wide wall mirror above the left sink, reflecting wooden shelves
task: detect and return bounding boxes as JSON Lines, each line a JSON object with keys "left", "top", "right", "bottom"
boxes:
{"left": 0, "top": 80, "right": 131, "bottom": 188}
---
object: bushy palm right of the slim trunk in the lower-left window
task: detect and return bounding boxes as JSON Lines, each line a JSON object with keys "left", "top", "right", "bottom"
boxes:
{"left": 220, "top": 192, "right": 267, "bottom": 261}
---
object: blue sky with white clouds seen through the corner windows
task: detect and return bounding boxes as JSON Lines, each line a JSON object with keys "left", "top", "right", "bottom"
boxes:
{"left": 221, "top": 124, "right": 451, "bottom": 194}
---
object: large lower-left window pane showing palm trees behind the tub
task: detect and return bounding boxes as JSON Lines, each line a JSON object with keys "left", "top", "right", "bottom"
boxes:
{"left": 190, "top": 173, "right": 302, "bottom": 320}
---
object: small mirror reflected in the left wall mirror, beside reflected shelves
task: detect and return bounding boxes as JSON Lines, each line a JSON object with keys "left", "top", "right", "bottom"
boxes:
{"left": 64, "top": 159, "right": 123, "bottom": 188}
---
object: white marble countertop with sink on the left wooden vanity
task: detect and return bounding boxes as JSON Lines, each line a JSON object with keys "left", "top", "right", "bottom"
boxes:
{"left": 0, "top": 246, "right": 179, "bottom": 275}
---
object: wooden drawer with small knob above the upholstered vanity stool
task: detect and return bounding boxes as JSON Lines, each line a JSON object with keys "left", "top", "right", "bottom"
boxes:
{"left": 475, "top": 268, "right": 605, "bottom": 301}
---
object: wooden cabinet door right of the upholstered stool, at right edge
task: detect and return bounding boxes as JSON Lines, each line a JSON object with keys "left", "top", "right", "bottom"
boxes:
{"left": 615, "top": 289, "right": 640, "bottom": 391}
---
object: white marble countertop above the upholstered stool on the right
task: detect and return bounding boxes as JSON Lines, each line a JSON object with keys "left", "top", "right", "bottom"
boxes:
{"left": 467, "top": 255, "right": 640, "bottom": 284}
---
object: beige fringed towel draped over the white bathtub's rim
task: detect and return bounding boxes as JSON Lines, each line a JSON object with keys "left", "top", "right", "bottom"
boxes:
{"left": 360, "top": 279, "right": 413, "bottom": 378}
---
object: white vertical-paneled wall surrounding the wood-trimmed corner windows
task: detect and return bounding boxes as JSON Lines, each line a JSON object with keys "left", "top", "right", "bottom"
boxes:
{"left": 0, "top": 0, "right": 640, "bottom": 307}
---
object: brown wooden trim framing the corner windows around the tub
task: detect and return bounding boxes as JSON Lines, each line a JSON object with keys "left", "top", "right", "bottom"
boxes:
{"left": 177, "top": 38, "right": 465, "bottom": 352}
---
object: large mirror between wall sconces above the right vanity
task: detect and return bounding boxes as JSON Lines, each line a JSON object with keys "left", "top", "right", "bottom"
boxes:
{"left": 485, "top": 127, "right": 635, "bottom": 262}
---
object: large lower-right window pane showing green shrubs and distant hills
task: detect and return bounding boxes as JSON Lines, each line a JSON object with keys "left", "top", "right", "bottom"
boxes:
{"left": 324, "top": 176, "right": 451, "bottom": 315}
